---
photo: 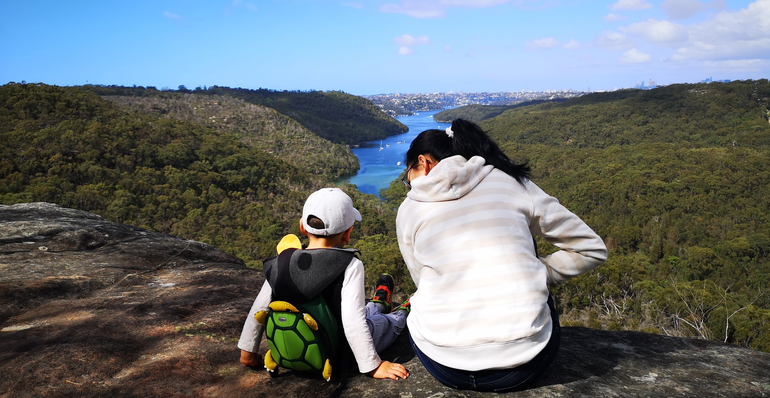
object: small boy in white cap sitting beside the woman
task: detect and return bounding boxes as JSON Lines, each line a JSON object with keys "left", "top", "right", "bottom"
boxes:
{"left": 238, "top": 188, "right": 409, "bottom": 380}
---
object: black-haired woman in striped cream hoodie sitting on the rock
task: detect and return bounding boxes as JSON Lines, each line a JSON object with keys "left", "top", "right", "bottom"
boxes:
{"left": 396, "top": 119, "right": 607, "bottom": 392}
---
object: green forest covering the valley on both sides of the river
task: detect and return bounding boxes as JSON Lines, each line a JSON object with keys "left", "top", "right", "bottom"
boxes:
{"left": 0, "top": 80, "right": 770, "bottom": 351}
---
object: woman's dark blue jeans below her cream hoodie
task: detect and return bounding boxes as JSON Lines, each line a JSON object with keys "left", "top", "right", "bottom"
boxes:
{"left": 409, "top": 297, "right": 561, "bottom": 392}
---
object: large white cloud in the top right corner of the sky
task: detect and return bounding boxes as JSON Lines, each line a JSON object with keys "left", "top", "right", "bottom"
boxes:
{"left": 671, "top": 0, "right": 770, "bottom": 61}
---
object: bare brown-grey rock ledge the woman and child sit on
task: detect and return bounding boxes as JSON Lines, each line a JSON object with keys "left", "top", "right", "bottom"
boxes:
{"left": 0, "top": 203, "right": 770, "bottom": 398}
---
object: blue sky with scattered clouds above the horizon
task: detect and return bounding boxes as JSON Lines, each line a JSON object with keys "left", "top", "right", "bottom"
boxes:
{"left": 0, "top": 0, "right": 770, "bottom": 95}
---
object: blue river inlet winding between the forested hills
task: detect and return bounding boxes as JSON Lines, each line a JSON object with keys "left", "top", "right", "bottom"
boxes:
{"left": 343, "top": 111, "right": 450, "bottom": 196}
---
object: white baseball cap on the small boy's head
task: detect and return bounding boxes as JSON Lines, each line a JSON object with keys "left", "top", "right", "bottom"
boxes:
{"left": 302, "top": 188, "right": 361, "bottom": 236}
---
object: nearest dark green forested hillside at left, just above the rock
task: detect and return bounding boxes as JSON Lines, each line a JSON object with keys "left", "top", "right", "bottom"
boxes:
{"left": 0, "top": 83, "right": 390, "bottom": 266}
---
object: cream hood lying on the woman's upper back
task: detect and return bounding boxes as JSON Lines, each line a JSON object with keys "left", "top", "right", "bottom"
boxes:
{"left": 407, "top": 155, "right": 494, "bottom": 202}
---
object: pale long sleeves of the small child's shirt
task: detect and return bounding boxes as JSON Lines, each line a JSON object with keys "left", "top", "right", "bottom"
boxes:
{"left": 238, "top": 258, "right": 382, "bottom": 373}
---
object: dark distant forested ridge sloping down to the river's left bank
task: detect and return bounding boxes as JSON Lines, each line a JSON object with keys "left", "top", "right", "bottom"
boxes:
{"left": 83, "top": 86, "right": 407, "bottom": 145}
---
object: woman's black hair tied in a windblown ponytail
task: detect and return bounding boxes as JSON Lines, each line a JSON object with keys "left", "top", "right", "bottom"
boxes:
{"left": 406, "top": 119, "right": 531, "bottom": 184}
